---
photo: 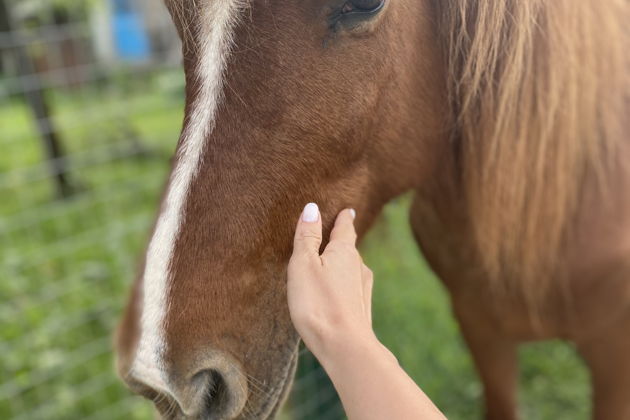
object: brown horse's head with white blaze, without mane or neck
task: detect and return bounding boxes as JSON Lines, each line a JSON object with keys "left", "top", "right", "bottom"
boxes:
{"left": 117, "top": 0, "right": 448, "bottom": 419}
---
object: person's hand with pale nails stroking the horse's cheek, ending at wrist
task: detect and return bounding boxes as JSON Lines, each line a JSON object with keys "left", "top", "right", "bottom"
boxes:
{"left": 287, "top": 203, "right": 376, "bottom": 360}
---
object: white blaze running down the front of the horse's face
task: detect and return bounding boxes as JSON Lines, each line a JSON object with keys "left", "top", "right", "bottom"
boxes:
{"left": 132, "top": 0, "right": 241, "bottom": 392}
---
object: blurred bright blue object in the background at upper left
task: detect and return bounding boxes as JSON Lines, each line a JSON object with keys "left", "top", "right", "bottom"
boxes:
{"left": 112, "top": 0, "right": 151, "bottom": 61}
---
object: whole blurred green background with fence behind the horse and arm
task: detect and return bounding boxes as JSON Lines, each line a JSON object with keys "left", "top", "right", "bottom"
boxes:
{"left": 0, "top": 0, "right": 589, "bottom": 420}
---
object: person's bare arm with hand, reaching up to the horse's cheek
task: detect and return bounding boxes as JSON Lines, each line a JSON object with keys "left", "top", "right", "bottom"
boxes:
{"left": 288, "top": 205, "right": 445, "bottom": 420}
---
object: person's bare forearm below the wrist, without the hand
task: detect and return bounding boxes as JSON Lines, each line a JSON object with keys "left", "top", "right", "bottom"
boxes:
{"left": 321, "top": 337, "right": 445, "bottom": 420}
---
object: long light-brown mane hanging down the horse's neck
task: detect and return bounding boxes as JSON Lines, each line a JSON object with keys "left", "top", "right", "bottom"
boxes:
{"left": 436, "top": 0, "right": 630, "bottom": 300}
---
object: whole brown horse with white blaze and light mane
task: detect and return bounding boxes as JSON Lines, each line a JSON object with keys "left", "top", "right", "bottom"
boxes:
{"left": 116, "top": 0, "right": 630, "bottom": 420}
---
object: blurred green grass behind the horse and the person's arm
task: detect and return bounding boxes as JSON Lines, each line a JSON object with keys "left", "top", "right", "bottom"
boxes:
{"left": 0, "top": 73, "right": 589, "bottom": 420}
